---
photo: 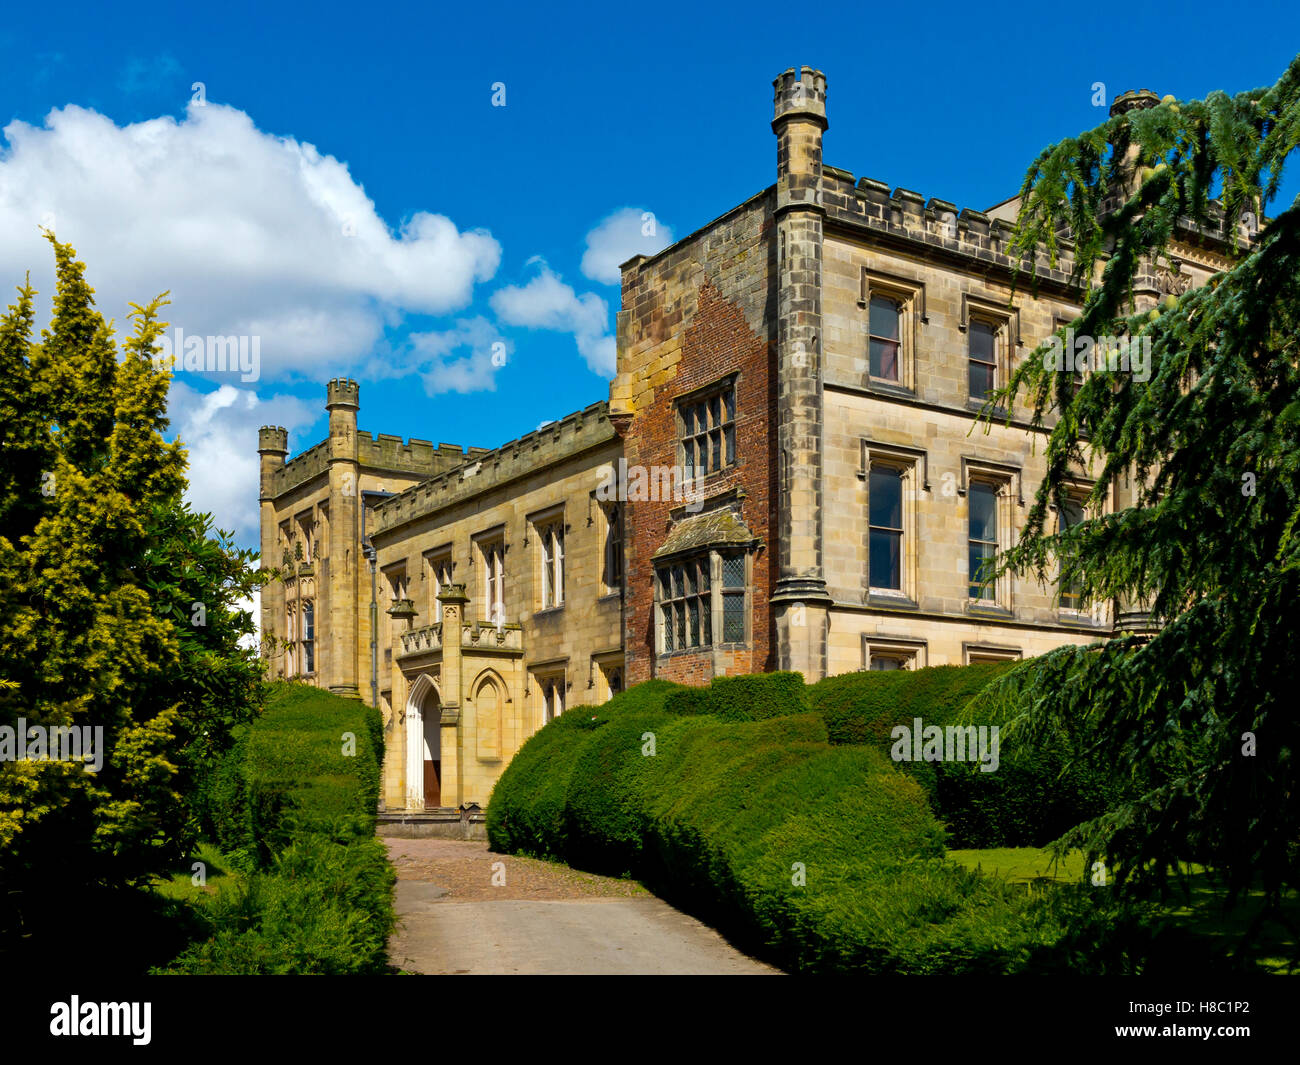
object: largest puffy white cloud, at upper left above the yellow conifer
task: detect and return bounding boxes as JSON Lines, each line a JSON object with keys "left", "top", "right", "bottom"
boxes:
{"left": 0, "top": 101, "right": 501, "bottom": 380}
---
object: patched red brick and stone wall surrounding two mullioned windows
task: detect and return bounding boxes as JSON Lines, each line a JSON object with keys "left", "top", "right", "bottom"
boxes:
{"left": 619, "top": 196, "right": 776, "bottom": 684}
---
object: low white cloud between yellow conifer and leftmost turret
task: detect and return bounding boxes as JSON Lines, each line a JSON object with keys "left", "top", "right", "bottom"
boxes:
{"left": 168, "top": 380, "right": 320, "bottom": 547}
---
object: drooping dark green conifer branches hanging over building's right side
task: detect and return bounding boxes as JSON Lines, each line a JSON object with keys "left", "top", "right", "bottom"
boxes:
{"left": 991, "top": 59, "right": 1300, "bottom": 941}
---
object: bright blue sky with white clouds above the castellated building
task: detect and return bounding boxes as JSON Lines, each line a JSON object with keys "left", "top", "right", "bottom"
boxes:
{"left": 0, "top": 3, "right": 1300, "bottom": 544}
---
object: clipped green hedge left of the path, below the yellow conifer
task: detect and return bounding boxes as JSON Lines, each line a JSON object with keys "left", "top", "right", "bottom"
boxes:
{"left": 165, "top": 684, "right": 395, "bottom": 974}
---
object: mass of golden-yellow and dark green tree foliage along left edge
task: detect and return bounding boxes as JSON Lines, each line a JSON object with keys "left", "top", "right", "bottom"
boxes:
{"left": 0, "top": 234, "right": 261, "bottom": 948}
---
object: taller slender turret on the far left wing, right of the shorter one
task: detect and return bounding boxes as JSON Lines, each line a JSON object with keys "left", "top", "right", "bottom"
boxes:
{"left": 325, "top": 377, "right": 368, "bottom": 696}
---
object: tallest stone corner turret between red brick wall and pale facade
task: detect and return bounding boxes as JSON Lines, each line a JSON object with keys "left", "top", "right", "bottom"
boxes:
{"left": 772, "top": 66, "right": 831, "bottom": 683}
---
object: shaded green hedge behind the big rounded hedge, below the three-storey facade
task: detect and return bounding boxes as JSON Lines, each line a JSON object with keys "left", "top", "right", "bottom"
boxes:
{"left": 807, "top": 662, "right": 1130, "bottom": 848}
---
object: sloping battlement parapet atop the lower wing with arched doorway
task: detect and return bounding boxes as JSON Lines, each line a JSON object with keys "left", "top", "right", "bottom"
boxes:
{"left": 374, "top": 401, "right": 618, "bottom": 536}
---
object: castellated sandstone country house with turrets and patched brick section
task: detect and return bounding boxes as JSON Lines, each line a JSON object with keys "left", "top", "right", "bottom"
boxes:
{"left": 259, "top": 68, "right": 1252, "bottom": 813}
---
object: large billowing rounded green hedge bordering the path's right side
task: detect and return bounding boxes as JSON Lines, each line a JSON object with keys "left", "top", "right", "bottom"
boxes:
{"left": 488, "top": 680, "right": 1062, "bottom": 973}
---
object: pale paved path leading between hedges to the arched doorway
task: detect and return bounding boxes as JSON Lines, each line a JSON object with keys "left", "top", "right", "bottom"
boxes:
{"left": 384, "top": 837, "right": 777, "bottom": 975}
